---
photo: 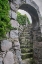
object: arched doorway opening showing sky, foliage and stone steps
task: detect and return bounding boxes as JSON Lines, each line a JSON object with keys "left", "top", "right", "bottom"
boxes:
{"left": 17, "top": 9, "right": 33, "bottom": 64}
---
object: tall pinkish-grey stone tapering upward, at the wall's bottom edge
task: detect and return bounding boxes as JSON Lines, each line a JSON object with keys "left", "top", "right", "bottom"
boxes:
{"left": 4, "top": 51, "right": 14, "bottom": 64}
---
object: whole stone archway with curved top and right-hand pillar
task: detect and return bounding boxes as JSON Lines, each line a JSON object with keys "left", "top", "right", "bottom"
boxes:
{"left": 9, "top": 0, "right": 42, "bottom": 64}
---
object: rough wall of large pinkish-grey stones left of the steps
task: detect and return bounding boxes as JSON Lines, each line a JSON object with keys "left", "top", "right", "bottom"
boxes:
{"left": 0, "top": 20, "right": 22, "bottom": 64}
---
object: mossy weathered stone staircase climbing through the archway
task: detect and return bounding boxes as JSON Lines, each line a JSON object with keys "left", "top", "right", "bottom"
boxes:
{"left": 19, "top": 25, "right": 33, "bottom": 64}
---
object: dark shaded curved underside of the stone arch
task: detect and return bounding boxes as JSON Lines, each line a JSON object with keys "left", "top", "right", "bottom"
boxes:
{"left": 19, "top": 4, "right": 39, "bottom": 29}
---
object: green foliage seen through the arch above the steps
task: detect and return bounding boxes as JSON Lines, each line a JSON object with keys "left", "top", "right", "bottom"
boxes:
{"left": 17, "top": 12, "right": 30, "bottom": 25}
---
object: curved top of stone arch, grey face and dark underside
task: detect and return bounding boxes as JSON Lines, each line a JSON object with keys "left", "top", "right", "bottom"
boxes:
{"left": 9, "top": 0, "right": 40, "bottom": 29}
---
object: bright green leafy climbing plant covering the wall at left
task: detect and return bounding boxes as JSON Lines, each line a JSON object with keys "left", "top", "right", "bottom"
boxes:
{"left": 0, "top": 0, "right": 11, "bottom": 39}
